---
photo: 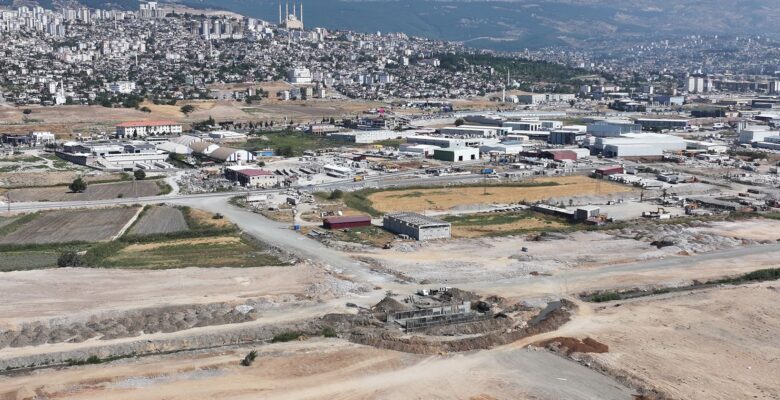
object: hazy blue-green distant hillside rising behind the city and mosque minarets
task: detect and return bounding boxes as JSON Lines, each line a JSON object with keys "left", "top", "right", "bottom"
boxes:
{"left": 6, "top": 0, "right": 780, "bottom": 50}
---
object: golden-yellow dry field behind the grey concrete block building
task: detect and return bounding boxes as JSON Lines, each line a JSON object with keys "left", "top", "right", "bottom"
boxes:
{"left": 369, "top": 176, "right": 632, "bottom": 212}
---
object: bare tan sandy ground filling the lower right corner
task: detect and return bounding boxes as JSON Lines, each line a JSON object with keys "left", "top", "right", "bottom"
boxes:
{"left": 568, "top": 282, "right": 780, "bottom": 400}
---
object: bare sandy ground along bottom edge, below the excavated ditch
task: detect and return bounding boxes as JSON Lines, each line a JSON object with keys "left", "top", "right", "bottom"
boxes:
{"left": 0, "top": 339, "right": 632, "bottom": 400}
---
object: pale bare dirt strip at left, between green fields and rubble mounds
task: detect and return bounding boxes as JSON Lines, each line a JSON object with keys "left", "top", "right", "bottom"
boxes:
{"left": 0, "top": 265, "right": 322, "bottom": 326}
